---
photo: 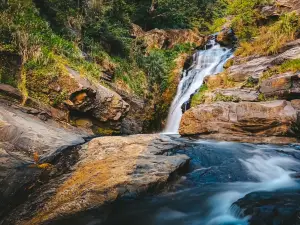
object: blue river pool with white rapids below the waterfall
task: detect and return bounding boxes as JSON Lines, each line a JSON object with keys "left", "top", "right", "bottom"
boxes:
{"left": 105, "top": 139, "right": 300, "bottom": 225}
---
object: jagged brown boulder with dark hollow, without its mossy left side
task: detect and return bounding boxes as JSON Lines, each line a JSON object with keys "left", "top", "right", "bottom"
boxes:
{"left": 55, "top": 68, "right": 129, "bottom": 133}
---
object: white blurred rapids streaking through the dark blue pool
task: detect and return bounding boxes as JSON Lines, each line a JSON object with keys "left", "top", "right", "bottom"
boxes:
{"left": 205, "top": 155, "right": 299, "bottom": 225}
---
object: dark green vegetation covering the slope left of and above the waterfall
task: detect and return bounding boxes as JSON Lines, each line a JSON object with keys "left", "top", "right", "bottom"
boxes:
{"left": 0, "top": 0, "right": 227, "bottom": 100}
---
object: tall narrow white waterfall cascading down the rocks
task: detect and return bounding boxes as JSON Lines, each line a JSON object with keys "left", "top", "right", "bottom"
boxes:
{"left": 165, "top": 37, "right": 232, "bottom": 134}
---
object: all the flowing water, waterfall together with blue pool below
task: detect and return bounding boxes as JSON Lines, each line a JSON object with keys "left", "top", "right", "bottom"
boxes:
{"left": 101, "top": 36, "right": 300, "bottom": 225}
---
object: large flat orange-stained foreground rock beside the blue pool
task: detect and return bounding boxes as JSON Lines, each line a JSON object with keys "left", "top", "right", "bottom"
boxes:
{"left": 2, "top": 135, "right": 189, "bottom": 225}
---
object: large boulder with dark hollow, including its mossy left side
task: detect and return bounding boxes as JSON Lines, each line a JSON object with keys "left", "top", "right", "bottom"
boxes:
{"left": 28, "top": 67, "right": 129, "bottom": 133}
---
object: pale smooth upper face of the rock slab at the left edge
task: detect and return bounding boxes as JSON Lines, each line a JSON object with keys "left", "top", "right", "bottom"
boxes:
{"left": 0, "top": 101, "right": 88, "bottom": 157}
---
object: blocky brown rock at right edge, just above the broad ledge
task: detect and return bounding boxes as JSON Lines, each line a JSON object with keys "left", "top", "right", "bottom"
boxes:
{"left": 260, "top": 73, "right": 300, "bottom": 99}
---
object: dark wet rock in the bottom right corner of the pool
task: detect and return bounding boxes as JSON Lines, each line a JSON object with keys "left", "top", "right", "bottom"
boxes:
{"left": 233, "top": 191, "right": 300, "bottom": 225}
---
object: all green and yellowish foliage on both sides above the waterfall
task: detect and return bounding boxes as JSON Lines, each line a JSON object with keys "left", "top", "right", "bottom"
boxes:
{"left": 0, "top": 0, "right": 300, "bottom": 129}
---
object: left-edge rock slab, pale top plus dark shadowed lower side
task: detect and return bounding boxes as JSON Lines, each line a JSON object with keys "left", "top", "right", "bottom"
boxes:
{"left": 0, "top": 100, "right": 89, "bottom": 219}
